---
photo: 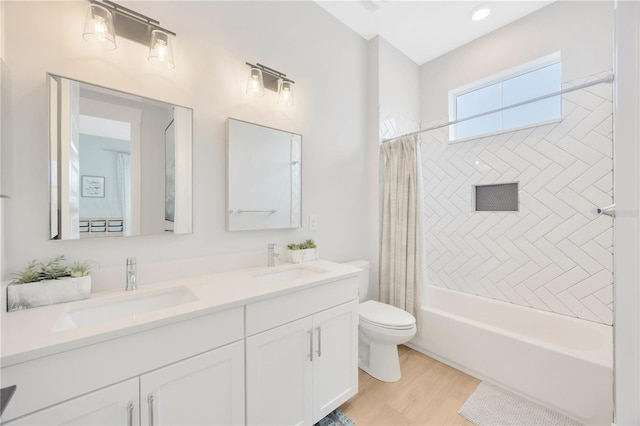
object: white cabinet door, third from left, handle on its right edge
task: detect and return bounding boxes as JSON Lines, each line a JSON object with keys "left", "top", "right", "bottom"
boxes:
{"left": 247, "top": 317, "right": 313, "bottom": 426}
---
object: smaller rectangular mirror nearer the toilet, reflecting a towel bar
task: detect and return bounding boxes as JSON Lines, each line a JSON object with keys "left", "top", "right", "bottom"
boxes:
{"left": 227, "top": 118, "right": 302, "bottom": 231}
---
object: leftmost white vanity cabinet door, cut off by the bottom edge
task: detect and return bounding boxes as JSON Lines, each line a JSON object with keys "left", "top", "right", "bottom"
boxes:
{"left": 6, "top": 377, "right": 140, "bottom": 426}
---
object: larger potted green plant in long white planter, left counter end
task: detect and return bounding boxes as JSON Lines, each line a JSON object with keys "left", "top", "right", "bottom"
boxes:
{"left": 7, "top": 255, "right": 91, "bottom": 312}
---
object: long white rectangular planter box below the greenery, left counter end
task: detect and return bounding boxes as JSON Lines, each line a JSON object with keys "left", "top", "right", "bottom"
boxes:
{"left": 7, "top": 275, "right": 91, "bottom": 312}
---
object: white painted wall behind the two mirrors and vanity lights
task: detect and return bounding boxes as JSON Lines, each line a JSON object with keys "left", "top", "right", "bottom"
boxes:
{"left": 2, "top": 1, "right": 370, "bottom": 286}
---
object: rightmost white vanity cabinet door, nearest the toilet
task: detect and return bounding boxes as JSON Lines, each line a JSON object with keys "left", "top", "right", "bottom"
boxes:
{"left": 312, "top": 300, "right": 358, "bottom": 423}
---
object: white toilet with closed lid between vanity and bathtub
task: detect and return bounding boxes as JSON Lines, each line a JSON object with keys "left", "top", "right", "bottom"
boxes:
{"left": 346, "top": 260, "right": 416, "bottom": 382}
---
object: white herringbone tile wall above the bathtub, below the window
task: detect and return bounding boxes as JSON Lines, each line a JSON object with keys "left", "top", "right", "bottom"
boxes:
{"left": 422, "top": 73, "right": 613, "bottom": 324}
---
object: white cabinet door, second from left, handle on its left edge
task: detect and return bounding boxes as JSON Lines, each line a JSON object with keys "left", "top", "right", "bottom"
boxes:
{"left": 140, "top": 341, "right": 244, "bottom": 426}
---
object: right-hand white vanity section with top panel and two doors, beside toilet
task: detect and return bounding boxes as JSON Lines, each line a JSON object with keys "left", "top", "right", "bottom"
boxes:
{"left": 246, "top": 278, "right": 358, "bottom": 425}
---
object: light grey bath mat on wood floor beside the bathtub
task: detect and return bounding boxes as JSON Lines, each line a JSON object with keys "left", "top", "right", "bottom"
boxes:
{"left": 458, "top": 382, "right": 580, "bottom": 426}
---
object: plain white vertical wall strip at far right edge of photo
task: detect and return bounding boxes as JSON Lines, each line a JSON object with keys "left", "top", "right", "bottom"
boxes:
{"left": 614, "top": 1, "right": 640, "bottom": 425}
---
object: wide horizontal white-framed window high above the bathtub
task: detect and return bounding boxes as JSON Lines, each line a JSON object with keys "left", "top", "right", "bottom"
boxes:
{"left": 449, "top": 52, "right": 562, "bottom": 141}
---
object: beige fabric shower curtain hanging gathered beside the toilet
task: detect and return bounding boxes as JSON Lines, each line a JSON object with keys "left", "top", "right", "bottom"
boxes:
{"left": 380, "top": 137, "right": 424, "bottom": 324}
